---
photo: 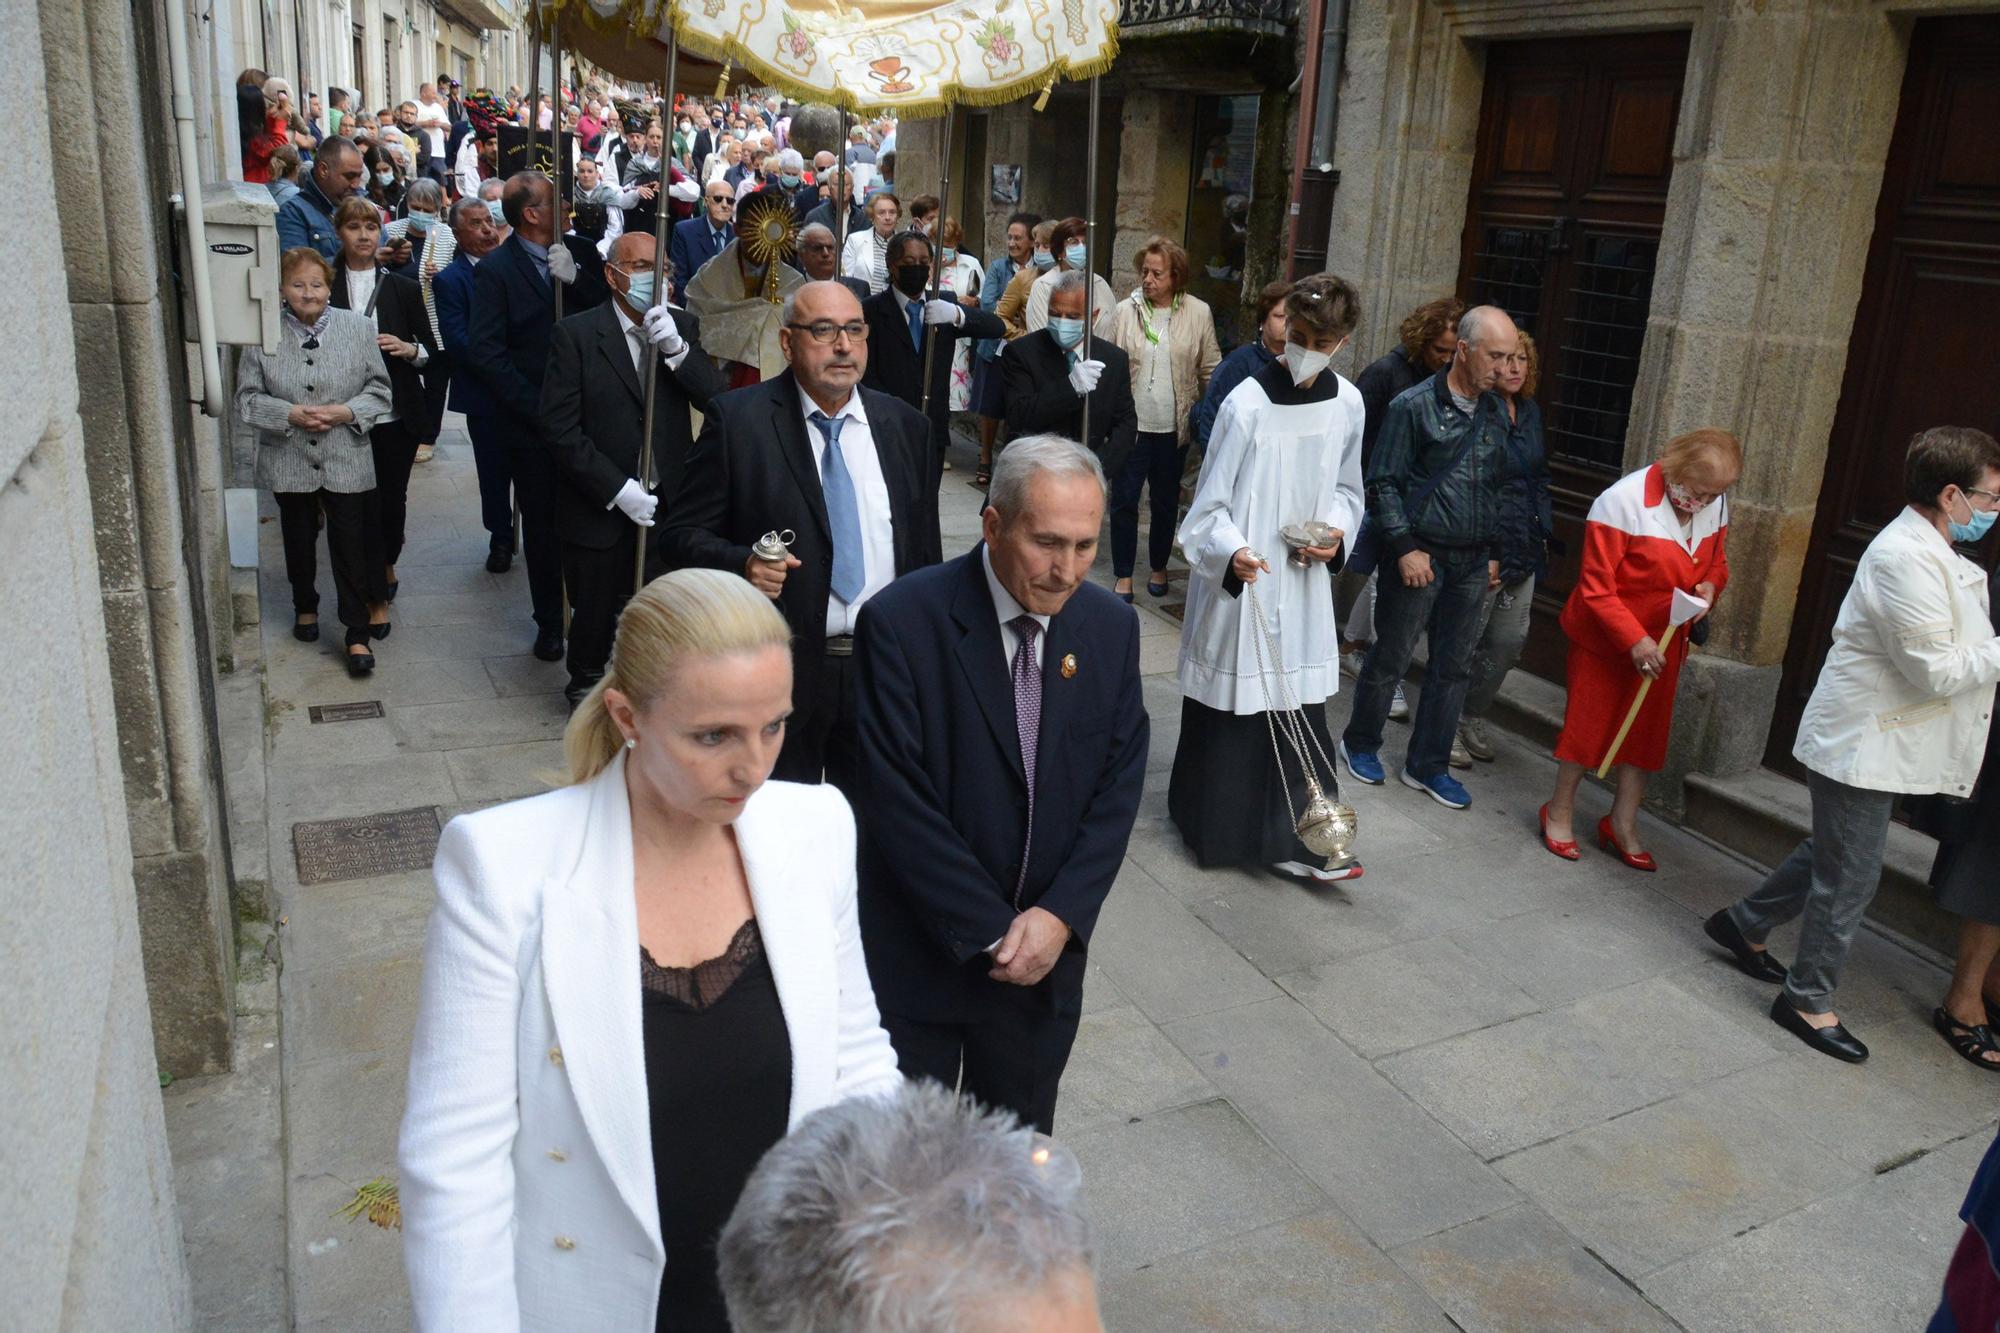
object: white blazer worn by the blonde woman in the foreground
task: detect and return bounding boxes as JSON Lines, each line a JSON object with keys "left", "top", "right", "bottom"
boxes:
{"left": 398, "top": 755, "right": 898, "bottom": 1333}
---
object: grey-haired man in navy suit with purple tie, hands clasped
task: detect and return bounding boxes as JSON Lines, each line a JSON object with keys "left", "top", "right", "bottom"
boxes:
{"left": 854, "top": 434, "right": 1150, "bottom": 1133}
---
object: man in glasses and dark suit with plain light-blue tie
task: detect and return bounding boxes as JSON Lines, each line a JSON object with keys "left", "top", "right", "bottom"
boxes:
{"left": 664, "top": 282, "right": 942, "bottom": 797}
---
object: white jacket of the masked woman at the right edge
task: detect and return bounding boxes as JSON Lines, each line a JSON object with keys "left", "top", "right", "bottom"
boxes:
{"left": 1792, "top": 508, "right": 2000, "bottom": 797}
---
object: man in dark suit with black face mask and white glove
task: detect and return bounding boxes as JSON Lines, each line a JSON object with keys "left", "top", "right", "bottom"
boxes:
{"left": 862, "top": 232, "right": 1006, "bottom": 484}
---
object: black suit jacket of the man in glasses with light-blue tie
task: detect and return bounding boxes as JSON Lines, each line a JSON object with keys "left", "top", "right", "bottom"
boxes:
{"left": 662, "top": 372, "right": 942, "bottom": 728}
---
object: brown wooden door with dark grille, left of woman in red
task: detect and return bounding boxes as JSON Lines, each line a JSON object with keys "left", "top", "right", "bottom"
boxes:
{"left": 1458, "top": 32, "right": 1688, "bottom": 681}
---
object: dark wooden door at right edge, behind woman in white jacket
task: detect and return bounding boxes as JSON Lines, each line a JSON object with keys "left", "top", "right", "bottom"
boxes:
{"left": 1746, "top": 16, "right": 2000, "bottom": 773}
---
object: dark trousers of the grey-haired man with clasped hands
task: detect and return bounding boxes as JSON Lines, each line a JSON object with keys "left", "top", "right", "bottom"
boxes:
{"left": 882, "top": 984, "right": 1082, "bottom": 1135}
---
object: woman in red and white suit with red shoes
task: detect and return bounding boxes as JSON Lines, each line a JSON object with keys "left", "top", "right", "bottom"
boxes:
{"left": 1542, "top": 428, "right": 1744, "bottom": 871}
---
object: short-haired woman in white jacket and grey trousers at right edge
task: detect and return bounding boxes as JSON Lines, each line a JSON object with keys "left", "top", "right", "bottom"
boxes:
{"left": 1706, "top": 426, "right": 2000, "bottom": 1065}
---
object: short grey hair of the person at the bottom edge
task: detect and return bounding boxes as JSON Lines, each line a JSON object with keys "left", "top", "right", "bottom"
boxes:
{"left": 716, "top": 1080, "right": 1094, "bottom": 1333}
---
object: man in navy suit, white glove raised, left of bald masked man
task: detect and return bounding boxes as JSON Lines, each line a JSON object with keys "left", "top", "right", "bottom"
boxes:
{"left": 466, "top": 172, "right": 608, "bottom": 662}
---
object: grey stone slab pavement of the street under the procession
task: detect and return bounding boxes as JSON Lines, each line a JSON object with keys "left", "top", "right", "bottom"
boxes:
{"left": 260, "top": 418, "right": 2000, "bottom": 1333}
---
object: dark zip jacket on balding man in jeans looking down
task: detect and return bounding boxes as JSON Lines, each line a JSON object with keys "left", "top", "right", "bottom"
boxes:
{"left": 1368, "top": 366, "right": 1508, "bottom": 560}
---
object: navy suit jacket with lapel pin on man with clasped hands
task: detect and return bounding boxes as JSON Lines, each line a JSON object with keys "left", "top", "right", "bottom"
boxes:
{"left": 854, "top": 546, "right": 1150, "bottom": 1023}
